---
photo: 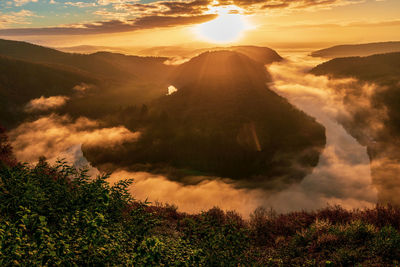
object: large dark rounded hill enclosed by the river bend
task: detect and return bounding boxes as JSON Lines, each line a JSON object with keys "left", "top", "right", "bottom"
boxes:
{"left": 84, "top": 51, "right": 325, "bottom": 190}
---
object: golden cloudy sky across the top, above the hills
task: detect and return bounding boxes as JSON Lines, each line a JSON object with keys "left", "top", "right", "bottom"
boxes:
{"left": 0, "top": 0, "right": 400, "bottom": 48}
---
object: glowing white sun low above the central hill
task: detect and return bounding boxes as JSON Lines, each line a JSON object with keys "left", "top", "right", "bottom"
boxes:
{"left": 195, "top": 6, "right": 250, "bottom": 43}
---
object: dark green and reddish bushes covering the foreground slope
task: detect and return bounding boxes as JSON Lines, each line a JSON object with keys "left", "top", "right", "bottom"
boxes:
{"left": 0, "top": 129, "right": 400, "bottom": 266}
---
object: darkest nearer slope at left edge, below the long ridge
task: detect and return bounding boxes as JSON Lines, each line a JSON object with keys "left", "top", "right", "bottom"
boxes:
{"left": 0, "top": 56, "right": 98, "bottom": 127}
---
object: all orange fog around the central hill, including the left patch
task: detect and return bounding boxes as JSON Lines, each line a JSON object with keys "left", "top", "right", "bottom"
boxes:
{"left": 10, "top": 51, "right": 377, "bottom": 217}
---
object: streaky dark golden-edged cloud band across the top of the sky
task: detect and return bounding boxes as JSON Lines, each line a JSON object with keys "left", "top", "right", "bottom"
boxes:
{"left": 0, "top": 0, "right": 364, "bottom": 36}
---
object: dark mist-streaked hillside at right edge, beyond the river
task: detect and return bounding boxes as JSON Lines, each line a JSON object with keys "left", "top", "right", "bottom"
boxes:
{"left": 311, "top": 52, "right": 400, "bottom": 205}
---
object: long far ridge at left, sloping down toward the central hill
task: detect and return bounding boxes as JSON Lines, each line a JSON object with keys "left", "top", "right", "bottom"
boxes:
{"left": 0, "top": 39, "right": 172, "bottom": 79}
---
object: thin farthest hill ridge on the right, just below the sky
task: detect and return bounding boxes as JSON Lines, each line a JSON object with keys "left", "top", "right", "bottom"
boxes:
{"left": 311, "top": 42, "right": 400, "bottom": 58}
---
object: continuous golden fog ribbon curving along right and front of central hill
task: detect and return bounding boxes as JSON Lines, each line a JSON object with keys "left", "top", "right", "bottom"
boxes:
{"left": 80, "top": 52, "right": 379, "bottom": 217}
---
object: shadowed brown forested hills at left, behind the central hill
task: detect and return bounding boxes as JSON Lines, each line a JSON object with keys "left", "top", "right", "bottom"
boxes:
{"left": 0, "top": 40, "right": 174, "bottom": 127}
